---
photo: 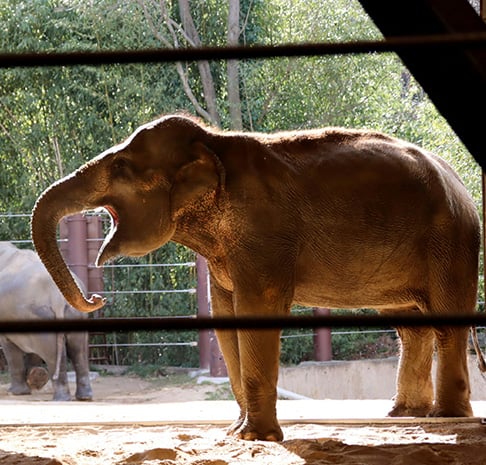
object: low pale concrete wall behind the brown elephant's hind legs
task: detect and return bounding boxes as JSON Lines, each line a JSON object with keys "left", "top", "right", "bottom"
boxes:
{"left": 278, "top": 356, "right": 486, "bottom": 400}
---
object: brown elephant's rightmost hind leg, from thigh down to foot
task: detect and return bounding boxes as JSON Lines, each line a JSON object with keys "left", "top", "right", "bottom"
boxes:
{"left": 429, "top": 224, "right": 479, "bottom": 417}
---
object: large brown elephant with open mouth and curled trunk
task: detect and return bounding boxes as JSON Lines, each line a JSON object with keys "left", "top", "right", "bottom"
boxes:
{"left": 32, "top": 115, "right": 480, "bottom": 440}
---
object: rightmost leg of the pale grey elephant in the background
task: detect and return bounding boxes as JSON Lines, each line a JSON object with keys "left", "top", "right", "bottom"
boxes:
{"left": 66, "top": 333, "right": 93, "bottom": 400}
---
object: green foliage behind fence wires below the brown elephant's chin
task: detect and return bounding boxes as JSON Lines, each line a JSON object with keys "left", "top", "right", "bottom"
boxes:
{"left": 103, "top": 242, "right": 199, "bottom": 367}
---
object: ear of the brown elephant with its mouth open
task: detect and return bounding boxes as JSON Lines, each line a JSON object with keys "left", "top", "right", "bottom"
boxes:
{"left": 170, "top": 142, "right": 224, "bottom": 218}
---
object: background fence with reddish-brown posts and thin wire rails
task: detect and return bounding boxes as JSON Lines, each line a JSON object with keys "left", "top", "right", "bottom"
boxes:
{"left": 0, "top": 212, "right": 338, "bottom": 376}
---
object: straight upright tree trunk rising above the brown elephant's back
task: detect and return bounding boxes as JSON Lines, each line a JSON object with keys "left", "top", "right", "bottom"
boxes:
{"left": 226, "top": 0, "right": 243, "bottom": 130}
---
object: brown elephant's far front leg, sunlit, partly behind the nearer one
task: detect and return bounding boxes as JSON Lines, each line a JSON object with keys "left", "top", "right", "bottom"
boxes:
{"left": 211, "top": 283, "right": 246, "bottom": 434}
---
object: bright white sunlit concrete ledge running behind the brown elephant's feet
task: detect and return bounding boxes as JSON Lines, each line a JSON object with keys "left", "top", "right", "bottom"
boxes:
{"left": 0, "top": 400, "right": 486, "bottom": 427}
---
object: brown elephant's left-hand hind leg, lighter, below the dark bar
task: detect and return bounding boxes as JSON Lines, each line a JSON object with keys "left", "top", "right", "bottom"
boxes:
{"left": 388, "top": 327, "right": 434, "bottom": 417}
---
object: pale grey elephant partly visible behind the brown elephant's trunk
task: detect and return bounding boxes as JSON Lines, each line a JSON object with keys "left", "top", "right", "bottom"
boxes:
{"left": 0, "top": 242, "right": 93, "bottom": 401}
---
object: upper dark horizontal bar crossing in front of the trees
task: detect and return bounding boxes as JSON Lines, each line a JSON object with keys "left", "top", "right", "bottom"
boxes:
{"left": 0, "top": 32, "right": 486, "bottom": 68}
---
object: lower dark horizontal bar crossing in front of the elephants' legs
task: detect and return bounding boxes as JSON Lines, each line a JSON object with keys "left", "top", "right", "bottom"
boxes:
{"left": 0, "top": 313, "right": 486, "bottom": 333}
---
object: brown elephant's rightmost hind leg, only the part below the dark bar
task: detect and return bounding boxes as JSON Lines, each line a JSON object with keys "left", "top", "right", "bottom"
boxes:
{"left": 430, "top": 327, "right": 473, "bottom": 417}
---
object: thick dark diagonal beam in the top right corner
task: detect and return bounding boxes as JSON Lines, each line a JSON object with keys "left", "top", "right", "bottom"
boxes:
{"left": 360, "top": 0, "right": 486, "bottom": 170}
